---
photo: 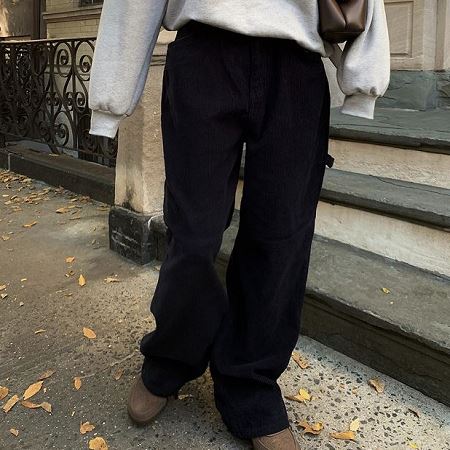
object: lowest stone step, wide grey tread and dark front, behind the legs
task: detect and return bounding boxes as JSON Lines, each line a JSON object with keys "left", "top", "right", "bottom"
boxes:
{"left": 151, "top": 210, "right": 450, "bottom": 405}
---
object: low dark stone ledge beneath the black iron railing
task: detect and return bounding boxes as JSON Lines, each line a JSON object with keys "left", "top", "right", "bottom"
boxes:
{"left": 0, "top": 145, "right": 115, "bottom": 204}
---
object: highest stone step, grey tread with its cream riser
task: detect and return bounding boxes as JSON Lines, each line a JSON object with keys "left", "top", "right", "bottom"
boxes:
{"left": 329, "top": 108, "right": 450, "bottom": 189}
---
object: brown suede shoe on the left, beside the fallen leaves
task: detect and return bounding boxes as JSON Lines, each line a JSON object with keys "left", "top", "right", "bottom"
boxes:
{"left": 127, "top": 376, "right": 167, "bottom": 425}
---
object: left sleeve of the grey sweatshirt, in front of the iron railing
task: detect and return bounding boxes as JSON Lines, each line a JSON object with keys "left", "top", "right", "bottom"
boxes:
{"left": 88, "top": 0, "right": 167, "bottom": 138}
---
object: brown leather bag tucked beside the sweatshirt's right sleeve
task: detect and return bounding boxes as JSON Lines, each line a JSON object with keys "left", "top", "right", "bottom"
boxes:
{"left": 319, "top": 0, "right": 368, "bottom": 43}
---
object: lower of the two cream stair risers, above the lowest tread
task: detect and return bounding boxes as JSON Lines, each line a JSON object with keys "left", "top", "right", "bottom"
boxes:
{"left": 315, "top": 201, "right": 450, "bottom": 276}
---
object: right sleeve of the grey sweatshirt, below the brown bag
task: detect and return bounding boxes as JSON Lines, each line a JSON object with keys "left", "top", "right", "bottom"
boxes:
{"left": 336, "top": 0, "right": 391, "bottom": 119}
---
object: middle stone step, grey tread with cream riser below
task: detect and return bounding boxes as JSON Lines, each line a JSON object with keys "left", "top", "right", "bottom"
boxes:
{"left": 316, "top": 169, "right": 450, "bottom": 276}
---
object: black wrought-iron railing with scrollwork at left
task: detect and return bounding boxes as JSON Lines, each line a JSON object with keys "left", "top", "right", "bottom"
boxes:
{"left": 0, "top": 38, "right": 118, "bottom": 167}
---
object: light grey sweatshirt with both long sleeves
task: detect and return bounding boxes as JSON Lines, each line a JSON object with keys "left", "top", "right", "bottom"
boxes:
{"left": 89, "top": 0, "right": 390, "bottom": 137}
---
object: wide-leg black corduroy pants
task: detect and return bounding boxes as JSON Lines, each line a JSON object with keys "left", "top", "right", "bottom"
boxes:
{"left": 141, "top": 21, "right": 332, "bottom": 438}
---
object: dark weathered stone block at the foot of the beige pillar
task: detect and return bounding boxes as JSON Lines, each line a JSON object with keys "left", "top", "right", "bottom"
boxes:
{"left": 109, "top": 206, "right": 157, "bottom": 264}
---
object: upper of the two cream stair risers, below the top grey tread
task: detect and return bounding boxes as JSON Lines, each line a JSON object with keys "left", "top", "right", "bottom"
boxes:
{"left": 329, "top": 139, "right": 450, "bottom": 189}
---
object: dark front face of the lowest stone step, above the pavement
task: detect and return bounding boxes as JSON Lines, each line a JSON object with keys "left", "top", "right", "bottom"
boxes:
{"left": 301, "top": 294, "right": 450, "bottom": 405}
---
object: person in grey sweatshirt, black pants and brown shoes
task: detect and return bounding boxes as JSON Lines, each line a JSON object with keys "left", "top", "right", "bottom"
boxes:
{"left": 89, "top": 0, "right": 390, "bottom": 450}
